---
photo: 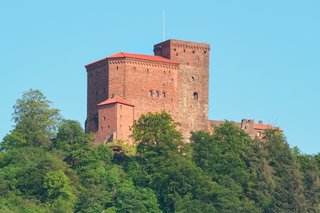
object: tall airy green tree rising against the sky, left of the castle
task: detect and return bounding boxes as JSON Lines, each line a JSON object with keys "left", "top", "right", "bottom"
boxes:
{"left": 1, "top": 89, "right": 61, "bottom": 149}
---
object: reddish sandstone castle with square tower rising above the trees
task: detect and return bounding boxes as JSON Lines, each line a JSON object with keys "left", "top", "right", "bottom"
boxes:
{"left": 85, "top": 40, "right": 274, "bottom": 143}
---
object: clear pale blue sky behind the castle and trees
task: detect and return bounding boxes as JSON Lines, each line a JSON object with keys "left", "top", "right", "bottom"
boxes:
{"left": 0, "top": 0, "right": 320, "bottom": 154}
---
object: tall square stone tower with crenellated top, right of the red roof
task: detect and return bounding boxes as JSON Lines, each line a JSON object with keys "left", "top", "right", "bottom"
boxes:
{"left": 153, "top": 40, "right": 210, "bottom": 139}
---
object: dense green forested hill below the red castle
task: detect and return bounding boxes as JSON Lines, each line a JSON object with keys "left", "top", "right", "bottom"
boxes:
{"left": 0, "top": 90, "right": 320, "bottom": 213}
